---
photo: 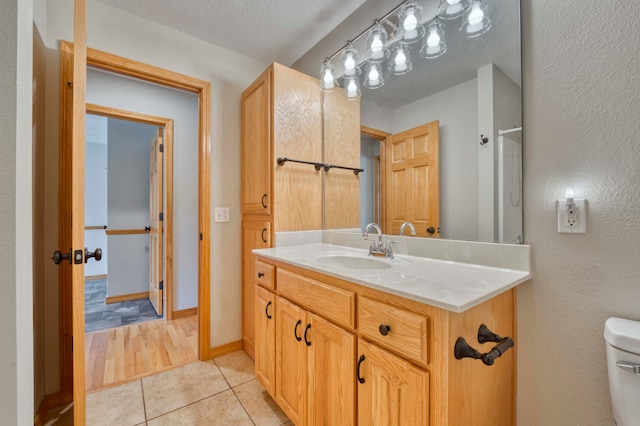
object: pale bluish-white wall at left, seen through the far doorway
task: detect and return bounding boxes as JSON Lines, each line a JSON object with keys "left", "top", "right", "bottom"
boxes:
{"left": 84, "top": 141, "right": 109, "bottom": 277}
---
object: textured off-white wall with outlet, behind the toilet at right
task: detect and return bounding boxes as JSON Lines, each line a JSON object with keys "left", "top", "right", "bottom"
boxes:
{"left": 516, "top": 0, "right": 640, "bottom": 426}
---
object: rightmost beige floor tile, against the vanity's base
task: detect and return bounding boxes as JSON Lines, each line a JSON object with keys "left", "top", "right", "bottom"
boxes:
{"left": 233, "top": 379, "right": 289, "bottom": 426}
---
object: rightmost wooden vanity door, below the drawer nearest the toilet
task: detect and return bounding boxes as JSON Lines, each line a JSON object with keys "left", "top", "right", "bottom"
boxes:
{"left": 357, "top": 340, "right": 429, "bottom": 426}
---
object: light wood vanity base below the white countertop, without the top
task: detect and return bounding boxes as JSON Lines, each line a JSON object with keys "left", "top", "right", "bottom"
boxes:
{"left": 256, "top": 256, "right": 517, "bottom": 426}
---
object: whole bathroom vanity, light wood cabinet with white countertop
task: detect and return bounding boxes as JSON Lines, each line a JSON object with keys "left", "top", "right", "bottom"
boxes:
{"left": 254, "top": 243, "right": 530, "bottom": 426}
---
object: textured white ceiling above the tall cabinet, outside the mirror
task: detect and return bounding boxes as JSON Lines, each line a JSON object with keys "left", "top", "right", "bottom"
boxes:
{"left": 94, "top": 0, "right": 364, "bottom": 65}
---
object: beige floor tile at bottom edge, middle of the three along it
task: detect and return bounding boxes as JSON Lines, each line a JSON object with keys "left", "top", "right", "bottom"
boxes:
{"left": 147, "top": 390, "right": 253, "bottom": 426}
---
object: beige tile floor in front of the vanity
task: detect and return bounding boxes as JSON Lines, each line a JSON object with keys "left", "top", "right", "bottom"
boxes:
{"left": 45, "top": 351, "right": 292, "bottom": 426}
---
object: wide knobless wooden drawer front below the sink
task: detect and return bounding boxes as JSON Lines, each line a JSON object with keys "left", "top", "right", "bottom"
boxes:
{"left": 276, "top": 268, "right": 355, "bottom": 328}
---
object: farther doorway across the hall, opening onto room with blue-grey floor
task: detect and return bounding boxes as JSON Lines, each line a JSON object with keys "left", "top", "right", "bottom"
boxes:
{"left": 85, "top": 104, "right": 175, "bottom": 333}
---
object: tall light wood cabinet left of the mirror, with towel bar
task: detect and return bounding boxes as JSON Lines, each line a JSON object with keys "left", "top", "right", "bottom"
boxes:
{"left": 241, "top": 63, "right": 323, "bottom": 358}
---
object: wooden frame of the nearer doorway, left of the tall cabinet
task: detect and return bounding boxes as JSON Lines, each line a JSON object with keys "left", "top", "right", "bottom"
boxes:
{"left": 58, "top": 41, "right": 211, "bottom": 402}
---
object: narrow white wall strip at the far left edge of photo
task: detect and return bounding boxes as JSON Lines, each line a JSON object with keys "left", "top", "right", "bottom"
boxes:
{"left": 0, "top": 0, "right": 34, "bottom": 425}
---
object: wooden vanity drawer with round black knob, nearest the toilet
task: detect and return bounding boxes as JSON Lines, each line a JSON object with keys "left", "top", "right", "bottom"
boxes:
{"left": 358, "top": 297, "right": 429, "bottom": 365}
